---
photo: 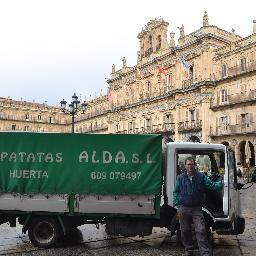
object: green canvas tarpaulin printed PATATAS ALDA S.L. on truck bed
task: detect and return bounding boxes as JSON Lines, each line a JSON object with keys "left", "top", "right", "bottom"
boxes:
{"left": 0, "top": 132, "right": 162, "bottom": 195}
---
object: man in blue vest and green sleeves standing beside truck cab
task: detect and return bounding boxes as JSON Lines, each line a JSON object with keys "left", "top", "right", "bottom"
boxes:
{"left": 173, "top": 157, "right": 223, "bottom": 256}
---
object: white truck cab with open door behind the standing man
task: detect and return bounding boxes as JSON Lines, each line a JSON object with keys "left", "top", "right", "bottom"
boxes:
{"left": 165, "top": 142, "right": 245, "bottom": 234}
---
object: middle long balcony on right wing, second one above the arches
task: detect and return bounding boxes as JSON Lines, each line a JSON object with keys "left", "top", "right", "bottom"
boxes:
{"left": 210, "top": 90, "right": 256, "bottom": 110}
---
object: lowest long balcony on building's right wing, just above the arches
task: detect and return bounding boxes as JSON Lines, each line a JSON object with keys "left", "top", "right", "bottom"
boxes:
{"left": 210, "top": 123, "right": 256, "bottom": 137}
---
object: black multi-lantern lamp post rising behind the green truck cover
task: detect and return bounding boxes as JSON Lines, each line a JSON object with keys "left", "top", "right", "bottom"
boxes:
{"left": 60, "top": 93, "right": 88, "bottom": 133}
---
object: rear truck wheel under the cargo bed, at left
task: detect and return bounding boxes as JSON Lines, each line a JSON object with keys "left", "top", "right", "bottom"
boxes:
{"left": 28, "top": 217, "right": 61, "bottom": 248}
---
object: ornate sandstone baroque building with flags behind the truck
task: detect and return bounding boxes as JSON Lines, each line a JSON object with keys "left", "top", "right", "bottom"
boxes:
{"left": 0, "top": 12, "right": 256, "bottom": 168}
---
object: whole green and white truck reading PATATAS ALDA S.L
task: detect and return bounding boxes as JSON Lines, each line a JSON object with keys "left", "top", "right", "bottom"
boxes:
{"left": 0, "top": 132, "right": 244, "bottom": 248}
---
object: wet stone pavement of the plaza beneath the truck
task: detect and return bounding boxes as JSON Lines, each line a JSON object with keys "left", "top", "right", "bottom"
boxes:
{"left": 0, "top": 184, "right": 256, "bottom": 256}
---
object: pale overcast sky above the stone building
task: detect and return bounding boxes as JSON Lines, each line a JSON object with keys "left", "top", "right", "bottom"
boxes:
{"left": 0, "top": 0, "right": 256, "bottom": 106}
